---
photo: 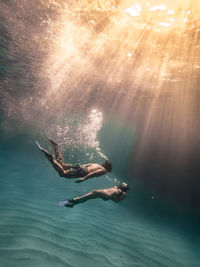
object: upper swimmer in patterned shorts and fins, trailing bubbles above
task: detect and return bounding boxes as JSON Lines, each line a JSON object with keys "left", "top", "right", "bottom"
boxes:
{"left": 36, "top": 138, "right": 112, "bottom": 183}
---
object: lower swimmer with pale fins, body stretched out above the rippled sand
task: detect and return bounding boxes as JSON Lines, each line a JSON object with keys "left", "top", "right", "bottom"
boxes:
{"left": 59, "top": 183, "right": 130, "bottom": 208}
